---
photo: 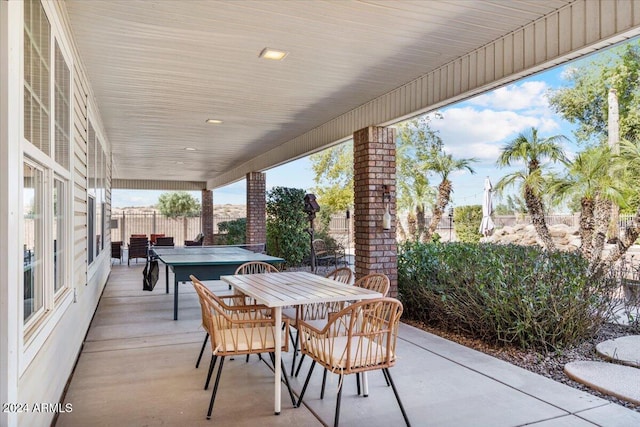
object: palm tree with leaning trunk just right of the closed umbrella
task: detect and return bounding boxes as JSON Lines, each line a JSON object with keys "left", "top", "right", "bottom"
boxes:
{"left": 496, "top": 127, "right": 567, "bottom": 250}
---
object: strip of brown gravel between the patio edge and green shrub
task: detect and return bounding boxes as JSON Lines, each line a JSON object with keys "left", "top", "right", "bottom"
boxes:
{"left": 403, "top": 320, "right": 640, "bottom": 412}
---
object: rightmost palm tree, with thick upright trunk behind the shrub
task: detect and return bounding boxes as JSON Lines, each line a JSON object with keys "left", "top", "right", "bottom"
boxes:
{"left": 549, "top": 146, "right": 625, "bottom": 268}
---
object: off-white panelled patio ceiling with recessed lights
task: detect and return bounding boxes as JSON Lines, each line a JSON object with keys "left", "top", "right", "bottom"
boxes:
{"left": 66, "top": 0, "right": 571, "bottom": 187}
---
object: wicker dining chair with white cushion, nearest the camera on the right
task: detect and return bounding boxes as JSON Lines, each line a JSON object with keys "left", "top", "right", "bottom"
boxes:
{"left": 297, "top": 298, "right": 410, "bottom": 426}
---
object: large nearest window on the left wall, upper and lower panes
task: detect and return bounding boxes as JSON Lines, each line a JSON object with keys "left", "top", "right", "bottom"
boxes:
{"left": 22, "top": 0, "right": 72, "bottom": 335}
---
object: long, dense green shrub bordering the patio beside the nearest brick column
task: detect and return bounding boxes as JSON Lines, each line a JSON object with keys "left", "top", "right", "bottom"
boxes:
{"left": 398, "top": 242, "right": 616, "bottom": 349}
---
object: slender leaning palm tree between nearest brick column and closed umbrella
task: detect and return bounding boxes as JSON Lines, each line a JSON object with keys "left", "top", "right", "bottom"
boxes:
{"left": 423, "top": 151, "right": 476, "bottom": 242}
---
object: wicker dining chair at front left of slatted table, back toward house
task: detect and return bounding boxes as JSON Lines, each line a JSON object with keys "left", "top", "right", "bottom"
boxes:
{"left": 191, "top": 276, "right": 296, "bottom": 419}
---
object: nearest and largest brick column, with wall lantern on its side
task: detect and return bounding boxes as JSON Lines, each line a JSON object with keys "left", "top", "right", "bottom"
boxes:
{"left": 353, "top": 126, "right": 398, "bottom": 297}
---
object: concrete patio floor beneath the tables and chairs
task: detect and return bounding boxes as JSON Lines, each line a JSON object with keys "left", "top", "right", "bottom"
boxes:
{"left": 55, "top": 264, "right": 640, "bottom": 427}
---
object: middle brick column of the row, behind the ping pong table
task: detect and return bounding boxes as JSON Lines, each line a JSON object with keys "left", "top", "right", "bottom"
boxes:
{"left": 246, "top": 172, "right": 267, "bottom": 244}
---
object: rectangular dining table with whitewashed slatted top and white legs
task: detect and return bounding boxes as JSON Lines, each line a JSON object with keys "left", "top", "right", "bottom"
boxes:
{"left": 220, "top": 271, "right": 383, "bottom": 415}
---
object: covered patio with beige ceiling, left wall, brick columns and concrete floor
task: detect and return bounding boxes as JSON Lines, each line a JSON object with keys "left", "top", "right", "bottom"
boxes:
{"left": 0, "top": 0, "right": 640, "bottom": 426}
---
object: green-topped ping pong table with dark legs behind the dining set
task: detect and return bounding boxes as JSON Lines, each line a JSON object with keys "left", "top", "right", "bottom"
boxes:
{"left": 152, "top": 246, "right": 284, "bottom": 320}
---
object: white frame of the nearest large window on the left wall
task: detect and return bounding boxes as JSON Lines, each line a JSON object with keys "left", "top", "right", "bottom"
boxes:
{"left": 18, "top": 0, "right": 75, "bottom": 354}
